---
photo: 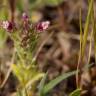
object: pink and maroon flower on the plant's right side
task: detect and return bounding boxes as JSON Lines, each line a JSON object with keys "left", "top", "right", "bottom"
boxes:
{"left": 36, "top": 21, "right": 50, "bottom": 31}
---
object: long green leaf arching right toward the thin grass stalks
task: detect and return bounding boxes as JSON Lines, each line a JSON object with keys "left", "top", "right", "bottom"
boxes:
{"left": 43, "top": 71, "right": 76, "bottom": 95}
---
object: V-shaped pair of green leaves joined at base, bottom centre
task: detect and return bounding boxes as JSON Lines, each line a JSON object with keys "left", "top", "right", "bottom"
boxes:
{"left": 39, "top": 71, "right": 77, "bottom": 96}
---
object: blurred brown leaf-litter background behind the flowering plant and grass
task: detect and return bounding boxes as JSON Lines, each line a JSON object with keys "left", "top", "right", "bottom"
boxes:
{"left": 0, "top": 0, "right": 96, "bottom": 96}
